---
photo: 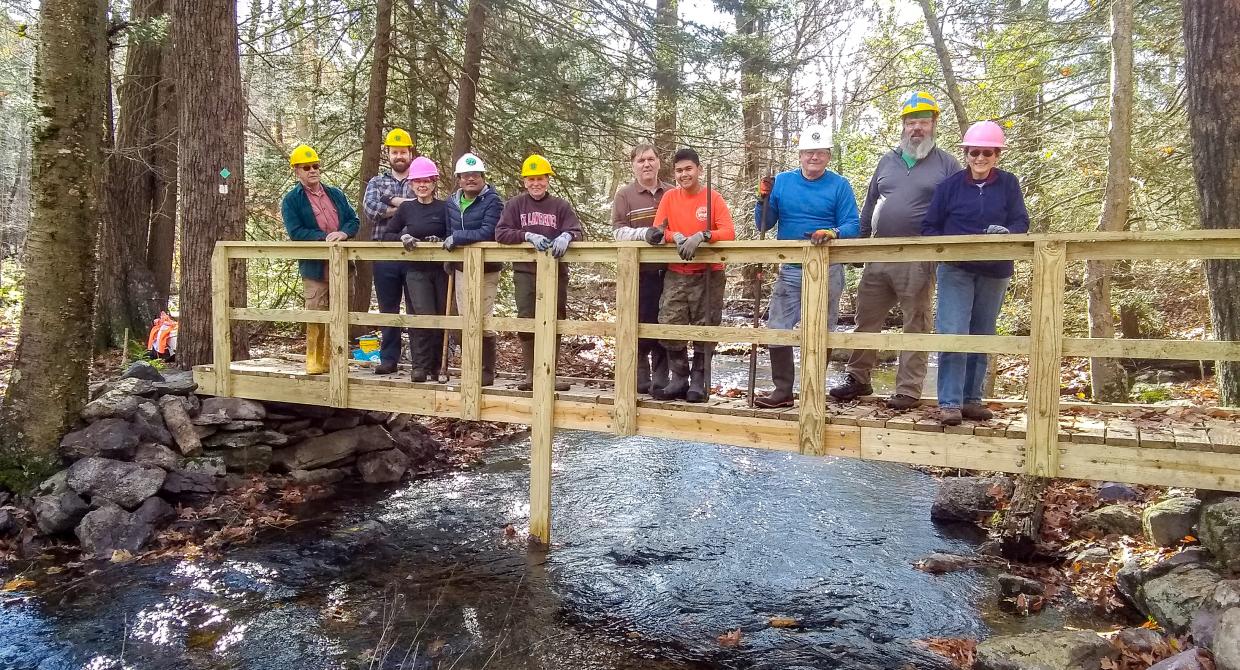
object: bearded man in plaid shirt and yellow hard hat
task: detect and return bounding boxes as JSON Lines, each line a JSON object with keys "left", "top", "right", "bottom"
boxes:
{"left": 362, "top": 128, "right": 417, "bottom": 375}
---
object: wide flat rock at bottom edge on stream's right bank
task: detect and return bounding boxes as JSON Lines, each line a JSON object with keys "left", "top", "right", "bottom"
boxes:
{"left": 973, "top": 630, "right": 1114, "bottom": 670}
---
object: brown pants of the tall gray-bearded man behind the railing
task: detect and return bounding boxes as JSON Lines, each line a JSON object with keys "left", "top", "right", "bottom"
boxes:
{"left": 846, "top": 262, "right": 935, "bottom": 398}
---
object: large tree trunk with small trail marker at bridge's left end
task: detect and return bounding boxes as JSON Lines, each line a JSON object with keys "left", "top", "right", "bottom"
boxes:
{"left": 171, "top": 0, "right": 248, "bottom": 367}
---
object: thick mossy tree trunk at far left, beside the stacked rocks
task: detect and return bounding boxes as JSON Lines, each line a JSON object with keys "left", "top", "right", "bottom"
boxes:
{"left": 0, "top": 0, "right": 108, "bottom": 489}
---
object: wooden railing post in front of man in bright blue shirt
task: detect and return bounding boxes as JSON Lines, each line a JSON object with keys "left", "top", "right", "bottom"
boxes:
{"left": 797, "top": 247, "right": 831, "bottom": 454}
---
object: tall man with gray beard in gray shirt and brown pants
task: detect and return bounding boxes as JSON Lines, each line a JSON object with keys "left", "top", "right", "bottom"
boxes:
{"left": 831, "top": 91, "right": 961, "bottom": 411}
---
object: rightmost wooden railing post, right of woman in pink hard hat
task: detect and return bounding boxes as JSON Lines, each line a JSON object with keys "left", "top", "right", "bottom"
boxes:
{"left": 1024, "top": 241, "right": 1068, "bottom": 476}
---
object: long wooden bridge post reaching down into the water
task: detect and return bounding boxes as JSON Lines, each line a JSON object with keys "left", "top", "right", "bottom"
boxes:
{"left": 529, "top": 253, "right": 567, "bottom": 545}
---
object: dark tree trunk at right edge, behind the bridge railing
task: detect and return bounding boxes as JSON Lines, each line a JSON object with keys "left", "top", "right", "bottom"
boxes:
{"left": 1184, "top": 0, "right": 1240, "bottom": 406}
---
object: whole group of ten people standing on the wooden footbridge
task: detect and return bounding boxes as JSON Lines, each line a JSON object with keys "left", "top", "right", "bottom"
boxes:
{"left": 281, "top": 91, "right": 1029, "bottom": 424}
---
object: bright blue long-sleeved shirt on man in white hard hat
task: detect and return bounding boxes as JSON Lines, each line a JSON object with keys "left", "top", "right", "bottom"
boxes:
{"left": 754, "top": 169, "right": 861, "bottom": 241}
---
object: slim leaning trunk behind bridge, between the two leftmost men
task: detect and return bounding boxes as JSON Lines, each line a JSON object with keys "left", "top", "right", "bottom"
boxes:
{"left": 350, "top": 0, "right": 392, "bottom": 320}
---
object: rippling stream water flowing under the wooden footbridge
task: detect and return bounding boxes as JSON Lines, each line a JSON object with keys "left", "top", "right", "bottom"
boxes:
{"left": 0, "top": 432, "right": 1066, "bottom": 670}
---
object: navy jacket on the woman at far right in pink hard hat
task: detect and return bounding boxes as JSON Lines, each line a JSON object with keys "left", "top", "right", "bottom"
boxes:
{"left": 921, "top": 168, "right": 1029, "bottom": 278}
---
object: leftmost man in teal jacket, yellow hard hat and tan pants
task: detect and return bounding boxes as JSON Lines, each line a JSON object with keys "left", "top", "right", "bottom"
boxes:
{"left": 280, "top": 144, "right": 360, "bottom": 375}
